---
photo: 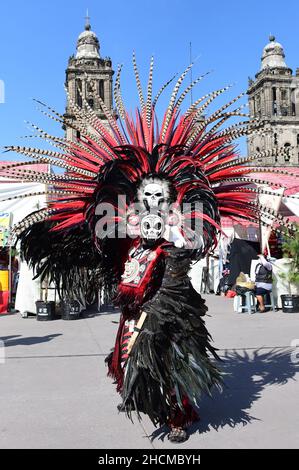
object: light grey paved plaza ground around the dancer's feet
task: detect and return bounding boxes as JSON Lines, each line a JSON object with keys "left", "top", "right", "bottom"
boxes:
{"left": 0, "top": 295, "right": 299, "bottom": 449}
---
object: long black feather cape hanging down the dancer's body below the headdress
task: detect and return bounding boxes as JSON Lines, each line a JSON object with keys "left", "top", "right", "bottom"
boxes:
{"left": 117, "top": 245, "right": 222, "bottom": 425}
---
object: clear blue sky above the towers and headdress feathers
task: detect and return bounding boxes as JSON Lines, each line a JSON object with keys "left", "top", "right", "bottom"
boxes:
{"left": 0, "top": 0, "right": 299, "bottom": 159}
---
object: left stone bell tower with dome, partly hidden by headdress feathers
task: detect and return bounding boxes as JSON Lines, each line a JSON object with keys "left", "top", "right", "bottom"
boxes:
{"left": 65, "top": 15, "right": 114, "bottom": 140}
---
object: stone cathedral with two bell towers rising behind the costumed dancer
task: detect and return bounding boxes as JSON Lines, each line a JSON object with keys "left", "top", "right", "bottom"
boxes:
{"left": 66, "top": 22, "right": 299, "bottom": 167}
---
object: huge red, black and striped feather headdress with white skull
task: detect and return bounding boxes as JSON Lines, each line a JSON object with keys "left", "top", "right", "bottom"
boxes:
{"left": 0, "top": 56, "right": 294, "bottom": 298}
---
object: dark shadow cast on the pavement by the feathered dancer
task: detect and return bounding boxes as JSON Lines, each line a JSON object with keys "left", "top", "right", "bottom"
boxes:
{"left": 151, "top": 349, "right": 299, "bottom": 441}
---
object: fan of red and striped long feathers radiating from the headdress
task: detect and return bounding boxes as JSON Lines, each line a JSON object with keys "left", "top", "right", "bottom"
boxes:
{"left": 0, "top": 54, "right": 298, "bottom": 250}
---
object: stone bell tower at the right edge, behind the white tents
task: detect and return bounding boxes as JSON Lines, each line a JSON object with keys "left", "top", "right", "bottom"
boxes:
{"left": 247, "top": 36, "right": 299, "bottom": 167}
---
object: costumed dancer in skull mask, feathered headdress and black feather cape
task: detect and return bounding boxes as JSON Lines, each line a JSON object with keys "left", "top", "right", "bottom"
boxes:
{"left": 1, "top": 58, "right": 298, "bottom": 442}
